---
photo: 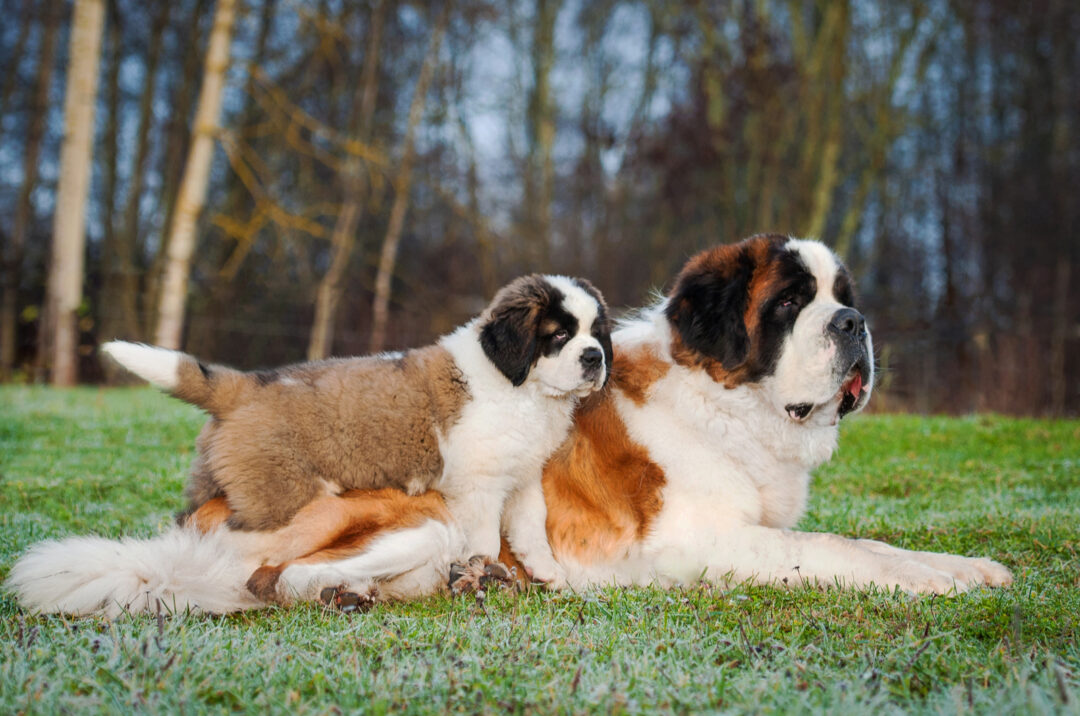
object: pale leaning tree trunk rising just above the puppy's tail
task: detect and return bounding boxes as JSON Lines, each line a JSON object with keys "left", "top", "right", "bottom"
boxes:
{"left": 154, "top": 0, "right": 235, "bottom": 349}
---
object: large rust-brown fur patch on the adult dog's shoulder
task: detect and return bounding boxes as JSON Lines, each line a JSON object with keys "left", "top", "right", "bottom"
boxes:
{"left": 543, "top": 381, "right": 665, "bottom": 564}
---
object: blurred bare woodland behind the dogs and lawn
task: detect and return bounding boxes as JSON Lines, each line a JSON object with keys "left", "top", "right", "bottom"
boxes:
{"left": 0, "top": 0, "right": 1080, "bottom": 415}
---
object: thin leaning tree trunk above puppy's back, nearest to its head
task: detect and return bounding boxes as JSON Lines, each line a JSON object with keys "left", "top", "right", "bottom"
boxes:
{"left": 369, "top": 2, "right": 451, "bottom": 353}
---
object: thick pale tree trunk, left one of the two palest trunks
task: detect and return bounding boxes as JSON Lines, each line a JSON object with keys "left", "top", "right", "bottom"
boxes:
{"left": 41, "top": 0, "right": 105, "bottom": 386}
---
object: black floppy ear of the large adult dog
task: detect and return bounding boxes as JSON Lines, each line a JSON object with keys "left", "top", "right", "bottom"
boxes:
{"left": 666, "top": 252, "right": 754, "bottom": 370}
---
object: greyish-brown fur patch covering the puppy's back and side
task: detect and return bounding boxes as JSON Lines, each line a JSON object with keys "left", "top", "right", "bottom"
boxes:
{"left": 175, "top": 346, "right": 469, "bottom": 530}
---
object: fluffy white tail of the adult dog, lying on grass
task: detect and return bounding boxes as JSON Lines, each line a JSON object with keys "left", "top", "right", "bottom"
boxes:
{"left": 6, "top": 527, "right": 264, "bottom": 618}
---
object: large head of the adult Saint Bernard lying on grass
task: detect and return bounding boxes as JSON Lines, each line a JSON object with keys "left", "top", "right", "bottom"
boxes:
{"left": 665, "top": 235, "right": 874, "bottom": 424}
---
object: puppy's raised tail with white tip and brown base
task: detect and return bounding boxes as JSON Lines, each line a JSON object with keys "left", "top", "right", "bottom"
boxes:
{"left": 102, "top": 340, "right": 250, "bottom": 417}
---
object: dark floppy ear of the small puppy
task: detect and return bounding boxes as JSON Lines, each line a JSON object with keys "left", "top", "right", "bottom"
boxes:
{"left": 480, "top": 275, "right": 551, "bottom": 386}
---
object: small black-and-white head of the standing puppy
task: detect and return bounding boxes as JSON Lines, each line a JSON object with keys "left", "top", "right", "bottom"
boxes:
{"left": 480, "top": 274, "right": 611, "bottom": 396}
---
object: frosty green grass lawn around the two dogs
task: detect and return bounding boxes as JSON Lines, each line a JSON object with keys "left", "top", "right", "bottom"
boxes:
{"left": 0, "top": 388, "right": 1080, "bottom": 714}
